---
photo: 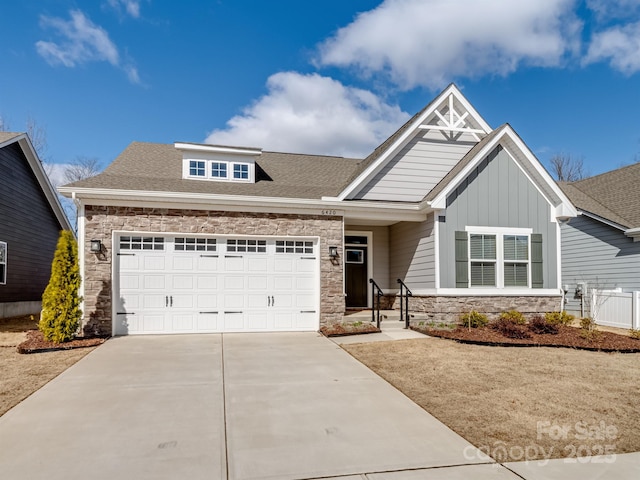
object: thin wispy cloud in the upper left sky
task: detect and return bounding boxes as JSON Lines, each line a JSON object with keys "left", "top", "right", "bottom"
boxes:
{"left": 36, "top": 10, "right": 140, "bottom": 83}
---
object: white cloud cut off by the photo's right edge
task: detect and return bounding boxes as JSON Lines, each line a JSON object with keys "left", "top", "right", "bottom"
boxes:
{"left": 583, "top": 22, "right": 640, "bottom": 75}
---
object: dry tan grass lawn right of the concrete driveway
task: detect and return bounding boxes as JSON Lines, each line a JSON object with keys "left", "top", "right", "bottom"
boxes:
{"left": 343, "top": 338, "right": 640, "bottom": 462}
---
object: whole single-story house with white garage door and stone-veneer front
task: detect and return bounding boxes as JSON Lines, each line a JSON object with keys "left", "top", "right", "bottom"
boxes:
{"left": 60, "top": 85, "right": 576, "bottom": 335}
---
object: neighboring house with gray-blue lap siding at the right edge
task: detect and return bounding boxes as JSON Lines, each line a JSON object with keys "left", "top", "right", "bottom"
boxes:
{"left": 561, "top": 163, "right": 640, "bottom": 316}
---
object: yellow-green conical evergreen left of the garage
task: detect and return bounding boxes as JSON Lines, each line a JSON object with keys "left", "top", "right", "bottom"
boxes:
{"left": 38, "top": 230, "right": 82, "bottom": 343}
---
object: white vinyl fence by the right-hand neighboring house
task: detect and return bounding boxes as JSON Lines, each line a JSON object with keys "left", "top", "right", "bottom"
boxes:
{"left": 591, "top": 289, "right": 640, "bottom": 329}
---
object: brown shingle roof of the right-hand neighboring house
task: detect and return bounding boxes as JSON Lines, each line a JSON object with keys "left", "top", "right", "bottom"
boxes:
{"left": 561, "top": 163, "right": 640, "bottom": 228}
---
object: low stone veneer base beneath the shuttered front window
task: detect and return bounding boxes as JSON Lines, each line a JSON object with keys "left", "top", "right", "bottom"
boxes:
{"left": 388, "top": 295, "right": 562, "bottom": 323}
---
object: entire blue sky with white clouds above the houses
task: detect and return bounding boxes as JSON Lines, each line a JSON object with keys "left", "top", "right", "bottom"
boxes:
{"left": 0, "top": 0, "right": 640, "bottom": 184}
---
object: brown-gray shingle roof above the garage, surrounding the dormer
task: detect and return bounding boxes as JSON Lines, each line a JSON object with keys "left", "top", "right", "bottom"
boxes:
{"left": 65, "top": 142, "right": 361, "bottom": 199}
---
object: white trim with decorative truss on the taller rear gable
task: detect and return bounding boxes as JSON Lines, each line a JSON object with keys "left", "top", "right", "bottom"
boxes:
{"left": 336, "top": 84, "right": 491, "bottom": 200}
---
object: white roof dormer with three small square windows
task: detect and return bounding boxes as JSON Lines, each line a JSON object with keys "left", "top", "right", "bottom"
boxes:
{"left": 175, "top": 143, "right": 262, "bottom": 183}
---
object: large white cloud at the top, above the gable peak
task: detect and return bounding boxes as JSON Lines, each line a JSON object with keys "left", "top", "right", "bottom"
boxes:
{"left": 318, "top": 0, "right": 582, "bottom": 90}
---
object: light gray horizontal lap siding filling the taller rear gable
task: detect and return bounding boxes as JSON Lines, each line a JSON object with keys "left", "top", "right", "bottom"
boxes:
{"left": 355, "top": 131, "right": 477, "bottom": 202}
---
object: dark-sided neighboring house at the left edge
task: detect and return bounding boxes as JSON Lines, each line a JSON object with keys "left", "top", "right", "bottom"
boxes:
{"left": 0, "top": 132, "right": 71, "bottom": 318}
